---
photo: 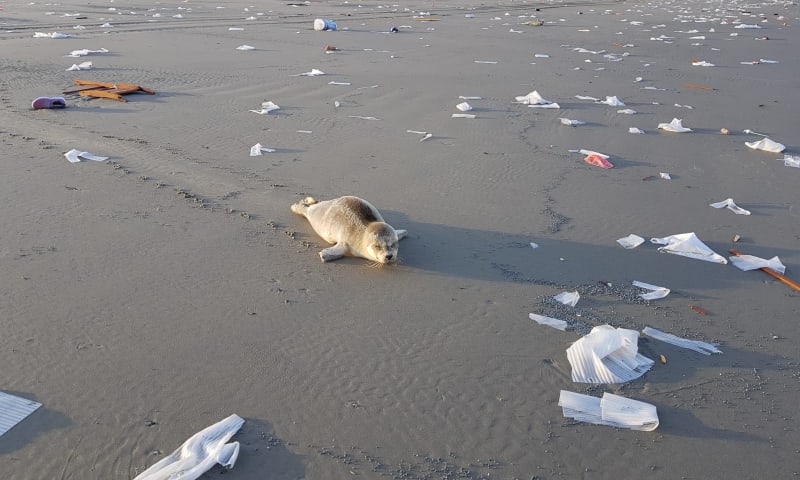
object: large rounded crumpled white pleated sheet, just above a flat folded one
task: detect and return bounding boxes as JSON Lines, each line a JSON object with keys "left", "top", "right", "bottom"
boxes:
{"left": 567, "top": 325, "right": 654, "bottom": 383}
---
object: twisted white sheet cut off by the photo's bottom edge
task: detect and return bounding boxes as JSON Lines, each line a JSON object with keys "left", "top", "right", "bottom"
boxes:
{"left": 134, "top": 414, "right": 244, "bottom": 480}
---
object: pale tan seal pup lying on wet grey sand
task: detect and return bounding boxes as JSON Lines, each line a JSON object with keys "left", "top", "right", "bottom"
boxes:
{"left": 292, "top": 196, "right": 408, "bottom": 265}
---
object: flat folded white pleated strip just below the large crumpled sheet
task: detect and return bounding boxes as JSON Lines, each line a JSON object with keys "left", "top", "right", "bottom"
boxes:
{"left": 558, "top": 390, "right": 659, "bottom": 432}
